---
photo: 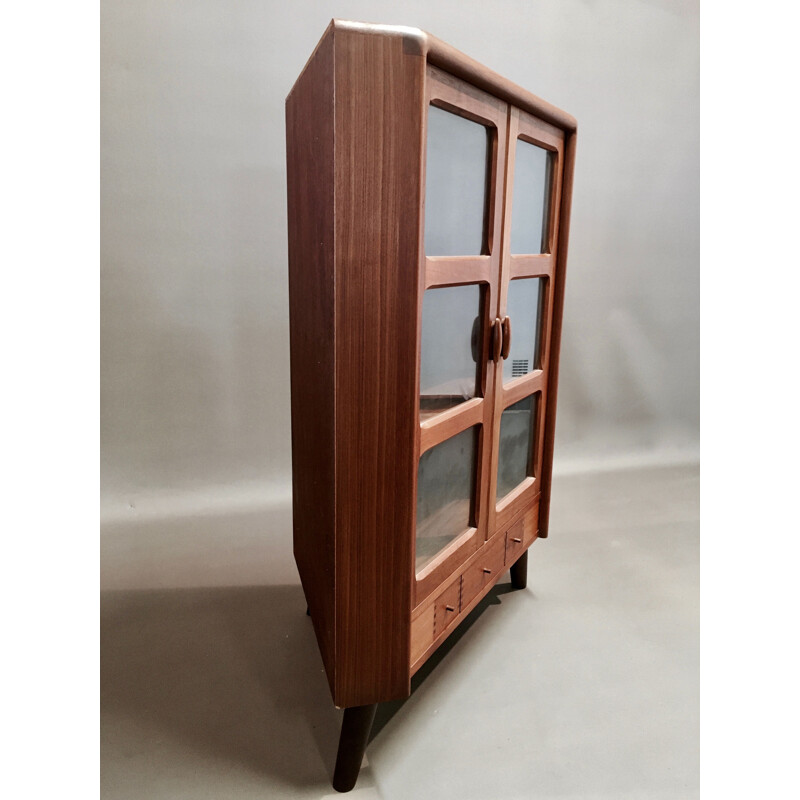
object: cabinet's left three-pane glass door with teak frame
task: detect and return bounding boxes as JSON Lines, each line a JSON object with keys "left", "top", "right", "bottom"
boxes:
{"left": 415, "top": 66, "right": 508, "bottom": 605}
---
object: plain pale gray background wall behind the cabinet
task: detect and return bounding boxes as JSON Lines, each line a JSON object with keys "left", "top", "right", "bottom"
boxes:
{"left": 101, "top": 0, "right": 699, "bottom": 536}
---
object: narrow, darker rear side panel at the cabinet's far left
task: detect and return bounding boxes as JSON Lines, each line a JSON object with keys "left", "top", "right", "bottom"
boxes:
{"left": 286, "top": 28, "right": 336, "bottom": 693}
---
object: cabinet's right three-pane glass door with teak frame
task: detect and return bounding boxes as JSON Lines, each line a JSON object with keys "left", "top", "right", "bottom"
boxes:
{"left": 489, "top": 107, "right": 564, "bottom": 532}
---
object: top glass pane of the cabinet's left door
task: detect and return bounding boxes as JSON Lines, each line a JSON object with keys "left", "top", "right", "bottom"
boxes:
{"left": 425, "top": 106, "right": 491, "bottom": 256}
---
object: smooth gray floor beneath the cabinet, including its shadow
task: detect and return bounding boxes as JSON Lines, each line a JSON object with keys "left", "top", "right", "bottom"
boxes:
{"left": 101, "top": 466, "right": 699, "bottom": 800}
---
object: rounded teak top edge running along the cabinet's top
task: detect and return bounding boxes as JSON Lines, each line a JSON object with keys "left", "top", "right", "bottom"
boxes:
{"left": 290, "top": 19, "right": 577, "bottom": 131}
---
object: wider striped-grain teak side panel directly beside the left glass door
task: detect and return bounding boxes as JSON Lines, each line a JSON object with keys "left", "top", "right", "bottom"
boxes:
{"left": 334, "top": 28, "right": 425, "bottom": 706}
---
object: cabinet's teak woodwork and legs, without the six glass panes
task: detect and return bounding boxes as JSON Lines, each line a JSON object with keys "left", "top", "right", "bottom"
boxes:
{"left": 286, "top": 21, "right": 576, "bottom": 791}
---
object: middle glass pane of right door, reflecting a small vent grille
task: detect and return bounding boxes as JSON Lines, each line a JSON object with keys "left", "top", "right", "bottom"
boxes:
{"left": 503, "top": 278, "right": 545, "bottom": 383}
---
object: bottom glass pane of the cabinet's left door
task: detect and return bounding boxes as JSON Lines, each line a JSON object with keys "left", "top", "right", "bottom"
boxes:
{"left": 416, "top": 426, "right": 478, "bottom": 571}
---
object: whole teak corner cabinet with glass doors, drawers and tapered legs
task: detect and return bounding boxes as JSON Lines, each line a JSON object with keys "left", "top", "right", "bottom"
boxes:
{"left": 286, "top": 21, "right": 576, "bottom": 790}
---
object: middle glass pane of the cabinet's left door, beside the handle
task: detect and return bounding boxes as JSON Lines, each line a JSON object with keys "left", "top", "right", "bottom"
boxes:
{"left": 419, "top": 283, "right": 481, "bottom": 420}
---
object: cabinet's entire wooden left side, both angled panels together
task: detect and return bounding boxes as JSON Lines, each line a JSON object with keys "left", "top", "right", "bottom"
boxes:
{"left": 286, "top": 24, "right": 425, "bottom": 707}
